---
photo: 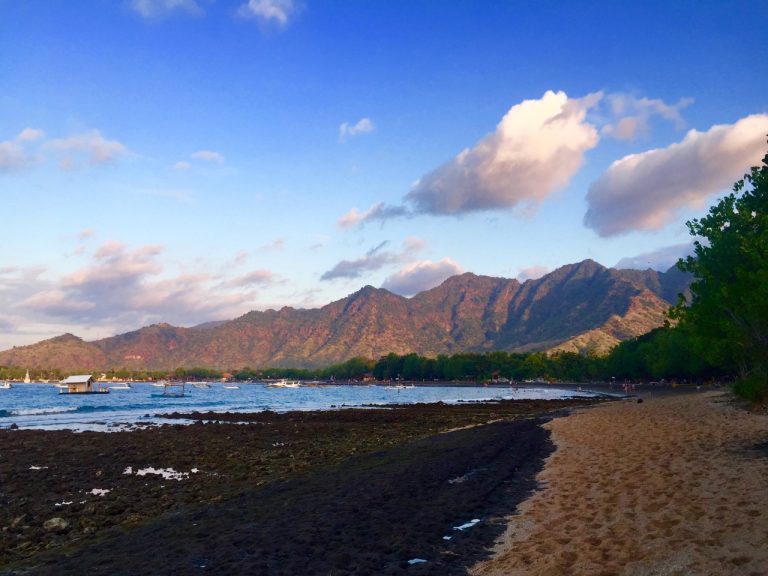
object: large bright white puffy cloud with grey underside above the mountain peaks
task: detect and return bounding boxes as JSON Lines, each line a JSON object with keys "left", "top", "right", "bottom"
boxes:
{"left": 406, "top": 91, "right": 602, "bottom": 214}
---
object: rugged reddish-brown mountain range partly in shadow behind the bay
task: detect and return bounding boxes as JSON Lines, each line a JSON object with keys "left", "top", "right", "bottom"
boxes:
{"left": 0, "top": 260, "right": 690, "bottom": 371}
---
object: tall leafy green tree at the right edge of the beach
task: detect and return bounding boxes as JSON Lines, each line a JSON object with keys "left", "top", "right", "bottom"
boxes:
{"left": 672, "top": 142, "right": 768, "bottom": 396}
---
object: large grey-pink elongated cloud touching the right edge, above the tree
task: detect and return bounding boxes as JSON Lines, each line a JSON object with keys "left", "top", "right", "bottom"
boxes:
{"left": 584, "top": 114, "right": 768, "bottom": 237}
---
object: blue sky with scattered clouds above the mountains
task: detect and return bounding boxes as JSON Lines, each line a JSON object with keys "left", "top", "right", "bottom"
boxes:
{"left": 0, "top": 0, "right": 768, "bottom": 349}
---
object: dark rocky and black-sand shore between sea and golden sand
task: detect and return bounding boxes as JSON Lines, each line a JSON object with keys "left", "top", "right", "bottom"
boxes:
{"left": 0, "top": 400, "right": 595, "bottom": 575}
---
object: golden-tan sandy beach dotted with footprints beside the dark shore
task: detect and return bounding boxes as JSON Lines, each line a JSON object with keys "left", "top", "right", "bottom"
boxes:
{"left": 471, "top": 392, "right": 768, "bottom": 576}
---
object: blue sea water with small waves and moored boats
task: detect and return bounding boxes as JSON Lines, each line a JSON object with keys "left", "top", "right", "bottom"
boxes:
{"left": 0, "top": 382, "right": 593, "bottom": 431}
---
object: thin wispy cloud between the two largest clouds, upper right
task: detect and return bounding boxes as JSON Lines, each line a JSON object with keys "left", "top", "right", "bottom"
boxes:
{"left": 601, "top": 94, "right": 693, "bottom": 140}
